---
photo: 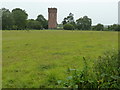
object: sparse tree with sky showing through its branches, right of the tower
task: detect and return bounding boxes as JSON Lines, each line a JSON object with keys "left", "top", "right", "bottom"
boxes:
{"left": 62, "top": 13, "right": 75, "bottom": 27}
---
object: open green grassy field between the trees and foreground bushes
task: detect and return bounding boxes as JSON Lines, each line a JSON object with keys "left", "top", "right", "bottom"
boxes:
{"left": 2, "top": 30, "right": 118, "bottom": 88}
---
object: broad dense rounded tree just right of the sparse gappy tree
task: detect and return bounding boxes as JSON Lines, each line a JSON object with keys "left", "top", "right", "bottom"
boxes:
{"left": 76, "top": 16, "right": 92, "bottom": 30}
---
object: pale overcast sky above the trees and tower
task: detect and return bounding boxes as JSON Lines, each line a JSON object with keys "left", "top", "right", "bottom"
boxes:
{"left": 0, "top": 0, "right": 119, "bottom": 25}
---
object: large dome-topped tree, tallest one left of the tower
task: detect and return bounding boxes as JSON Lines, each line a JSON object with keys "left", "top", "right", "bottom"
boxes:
{"left": 12, "top": 8, "right": 28, "bottom": 30}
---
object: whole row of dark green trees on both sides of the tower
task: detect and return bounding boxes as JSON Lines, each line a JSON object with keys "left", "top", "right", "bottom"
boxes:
{"left": 0, "top": 8, "right": 120, "bottom": 31}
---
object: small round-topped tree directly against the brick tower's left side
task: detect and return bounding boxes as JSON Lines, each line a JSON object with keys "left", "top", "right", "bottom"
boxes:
{"left": 36, "top": 14, "right": 48, "bottom": 29}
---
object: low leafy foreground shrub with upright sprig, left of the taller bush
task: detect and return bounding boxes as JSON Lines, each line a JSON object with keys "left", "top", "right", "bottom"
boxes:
{"left": 57, "top": 57, "right": 97, "bottom": 88}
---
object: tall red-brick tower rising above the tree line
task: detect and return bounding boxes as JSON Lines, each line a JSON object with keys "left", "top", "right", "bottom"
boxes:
{"left": 48, "top": 8, "right": 57, "bottom": 29}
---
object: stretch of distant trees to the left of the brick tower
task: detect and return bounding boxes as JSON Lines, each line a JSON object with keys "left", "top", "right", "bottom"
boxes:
{"left": 1, "top": 8, "right": 48, "bottom": 30}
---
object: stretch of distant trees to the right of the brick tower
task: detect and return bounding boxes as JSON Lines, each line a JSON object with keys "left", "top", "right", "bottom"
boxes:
{"left": 62, "top": 13, "right": 120, "bottom": 31}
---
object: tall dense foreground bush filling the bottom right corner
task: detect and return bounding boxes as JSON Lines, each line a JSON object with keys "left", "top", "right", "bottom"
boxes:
{"left": 93, "top": 50, "right": 120, "bottom": 89}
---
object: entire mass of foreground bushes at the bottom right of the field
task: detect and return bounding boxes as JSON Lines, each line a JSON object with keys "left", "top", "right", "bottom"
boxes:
{"left": 58, "top": 50, "right": 120, "bottom": 89}
